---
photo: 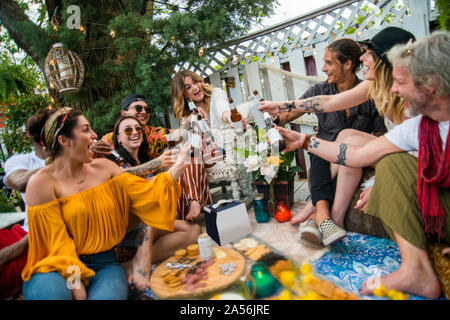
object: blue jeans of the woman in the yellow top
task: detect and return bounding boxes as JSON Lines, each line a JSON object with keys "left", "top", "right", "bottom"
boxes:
{"left": 23, "top": 250, "right": 128, "bottom": 300}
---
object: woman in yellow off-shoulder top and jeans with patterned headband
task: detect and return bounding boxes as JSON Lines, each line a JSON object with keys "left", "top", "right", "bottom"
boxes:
{"left": 22, "top": 108, "right": 189, "bottom": 300}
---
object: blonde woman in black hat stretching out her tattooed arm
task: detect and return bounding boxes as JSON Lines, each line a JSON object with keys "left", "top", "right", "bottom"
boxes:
{"left": 260, "top": 27, "right": 415, "bottom": 238}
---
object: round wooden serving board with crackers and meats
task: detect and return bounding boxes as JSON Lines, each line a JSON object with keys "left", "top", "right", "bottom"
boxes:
{"left": 150, "top": 247, "right": 245, "bottom": 299}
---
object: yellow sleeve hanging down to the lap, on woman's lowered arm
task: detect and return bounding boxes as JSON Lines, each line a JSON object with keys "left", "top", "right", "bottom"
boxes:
{"left": 22, "top": 200, "right": 95, "bottom": 285}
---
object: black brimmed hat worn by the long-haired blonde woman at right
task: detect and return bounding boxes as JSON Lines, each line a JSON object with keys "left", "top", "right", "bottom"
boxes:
{"left": 358, "top": 27, "right": 416, "bottom": 68}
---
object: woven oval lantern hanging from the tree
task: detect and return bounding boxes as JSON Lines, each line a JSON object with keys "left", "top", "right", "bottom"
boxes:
{"left": 44, "top": 43, "right": 84, "bottom": 93}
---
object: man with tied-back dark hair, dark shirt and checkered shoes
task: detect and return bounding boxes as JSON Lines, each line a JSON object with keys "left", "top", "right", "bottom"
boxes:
{"left": 272, "top": 39, "right": 386, "bottom": 245}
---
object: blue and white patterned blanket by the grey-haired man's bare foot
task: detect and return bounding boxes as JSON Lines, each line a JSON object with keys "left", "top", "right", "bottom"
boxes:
{"left": 311, "top": 232, "right": 444, "bottom": 300}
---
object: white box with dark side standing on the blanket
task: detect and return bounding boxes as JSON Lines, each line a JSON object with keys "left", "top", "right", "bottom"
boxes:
{"left": 203, "top": 200, "right": 253, "bottom": 246}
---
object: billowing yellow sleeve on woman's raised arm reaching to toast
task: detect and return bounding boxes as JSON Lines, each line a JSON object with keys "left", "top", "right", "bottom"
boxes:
{"left": 122, "top": 170, "right": 181, "bottom": 231}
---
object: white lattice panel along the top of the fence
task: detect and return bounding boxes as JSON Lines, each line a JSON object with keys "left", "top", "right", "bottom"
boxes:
{"left": 183, "top": 0, "right": 434, "bottom": 88}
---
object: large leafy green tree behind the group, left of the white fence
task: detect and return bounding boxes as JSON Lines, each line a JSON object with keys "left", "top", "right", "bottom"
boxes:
{"left": 1, "top": 0, "right": 276, "bottom": 135}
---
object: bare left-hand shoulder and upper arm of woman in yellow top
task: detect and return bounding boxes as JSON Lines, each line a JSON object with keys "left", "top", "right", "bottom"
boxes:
{"left": 26, "top": 168, "right": 57, "bottom": 206}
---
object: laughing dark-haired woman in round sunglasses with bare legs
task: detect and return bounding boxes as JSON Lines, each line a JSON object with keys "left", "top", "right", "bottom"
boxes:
{"left": 109, "top": 116, "right": 201, "bottom": 290}
